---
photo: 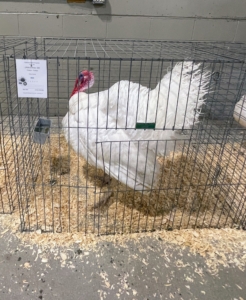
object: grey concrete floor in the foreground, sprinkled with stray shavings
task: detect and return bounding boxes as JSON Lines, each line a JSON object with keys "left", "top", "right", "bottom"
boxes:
{"left": 0, "top": 227, "right": 246, "bottom": 300}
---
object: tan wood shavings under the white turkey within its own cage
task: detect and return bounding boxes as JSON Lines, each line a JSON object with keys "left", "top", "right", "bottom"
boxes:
{"left": 1, "top": 135, "right": 243, "bottom": 234}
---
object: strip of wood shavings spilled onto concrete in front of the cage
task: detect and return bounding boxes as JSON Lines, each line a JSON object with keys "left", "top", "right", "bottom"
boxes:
{"left": 0, "top": 215, "right": 246, "bottom": 277}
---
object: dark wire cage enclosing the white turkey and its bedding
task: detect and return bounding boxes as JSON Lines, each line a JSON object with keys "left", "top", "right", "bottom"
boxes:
{"left": 0, "top": 38, "right": 246, "bottom": 234}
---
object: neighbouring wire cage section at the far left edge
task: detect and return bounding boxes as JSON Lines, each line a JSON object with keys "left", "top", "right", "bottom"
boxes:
{"left": 0, "top": 38, "right": 37, "bottom": 213}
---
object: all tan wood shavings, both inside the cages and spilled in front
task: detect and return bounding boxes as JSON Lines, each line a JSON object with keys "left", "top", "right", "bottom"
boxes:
{"left": 0, "top": 136, "right": 246, "bottom": 272}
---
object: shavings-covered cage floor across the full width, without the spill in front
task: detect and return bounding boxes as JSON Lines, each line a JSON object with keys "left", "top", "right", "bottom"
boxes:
{"left": 1, "top": 135, "right": 246, "bottom": 234}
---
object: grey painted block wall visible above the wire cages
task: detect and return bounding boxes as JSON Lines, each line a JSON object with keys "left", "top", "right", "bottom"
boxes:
{"left": 0, "top": 0, "right": 246, "bottom": 42}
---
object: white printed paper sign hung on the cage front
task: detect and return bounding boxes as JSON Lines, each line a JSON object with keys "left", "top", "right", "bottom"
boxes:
{"left": 16, "top": 59, "right": 47, "bottom": 98}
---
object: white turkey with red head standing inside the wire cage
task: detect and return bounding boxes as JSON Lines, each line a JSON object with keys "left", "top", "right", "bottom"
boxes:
{"left": 62, "top": 61, "right": 211, "bottom": 190}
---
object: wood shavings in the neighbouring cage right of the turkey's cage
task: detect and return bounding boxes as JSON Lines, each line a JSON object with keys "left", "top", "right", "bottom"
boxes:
{"left": 191, "top": 142, "right": 246, "bottom": 222}
